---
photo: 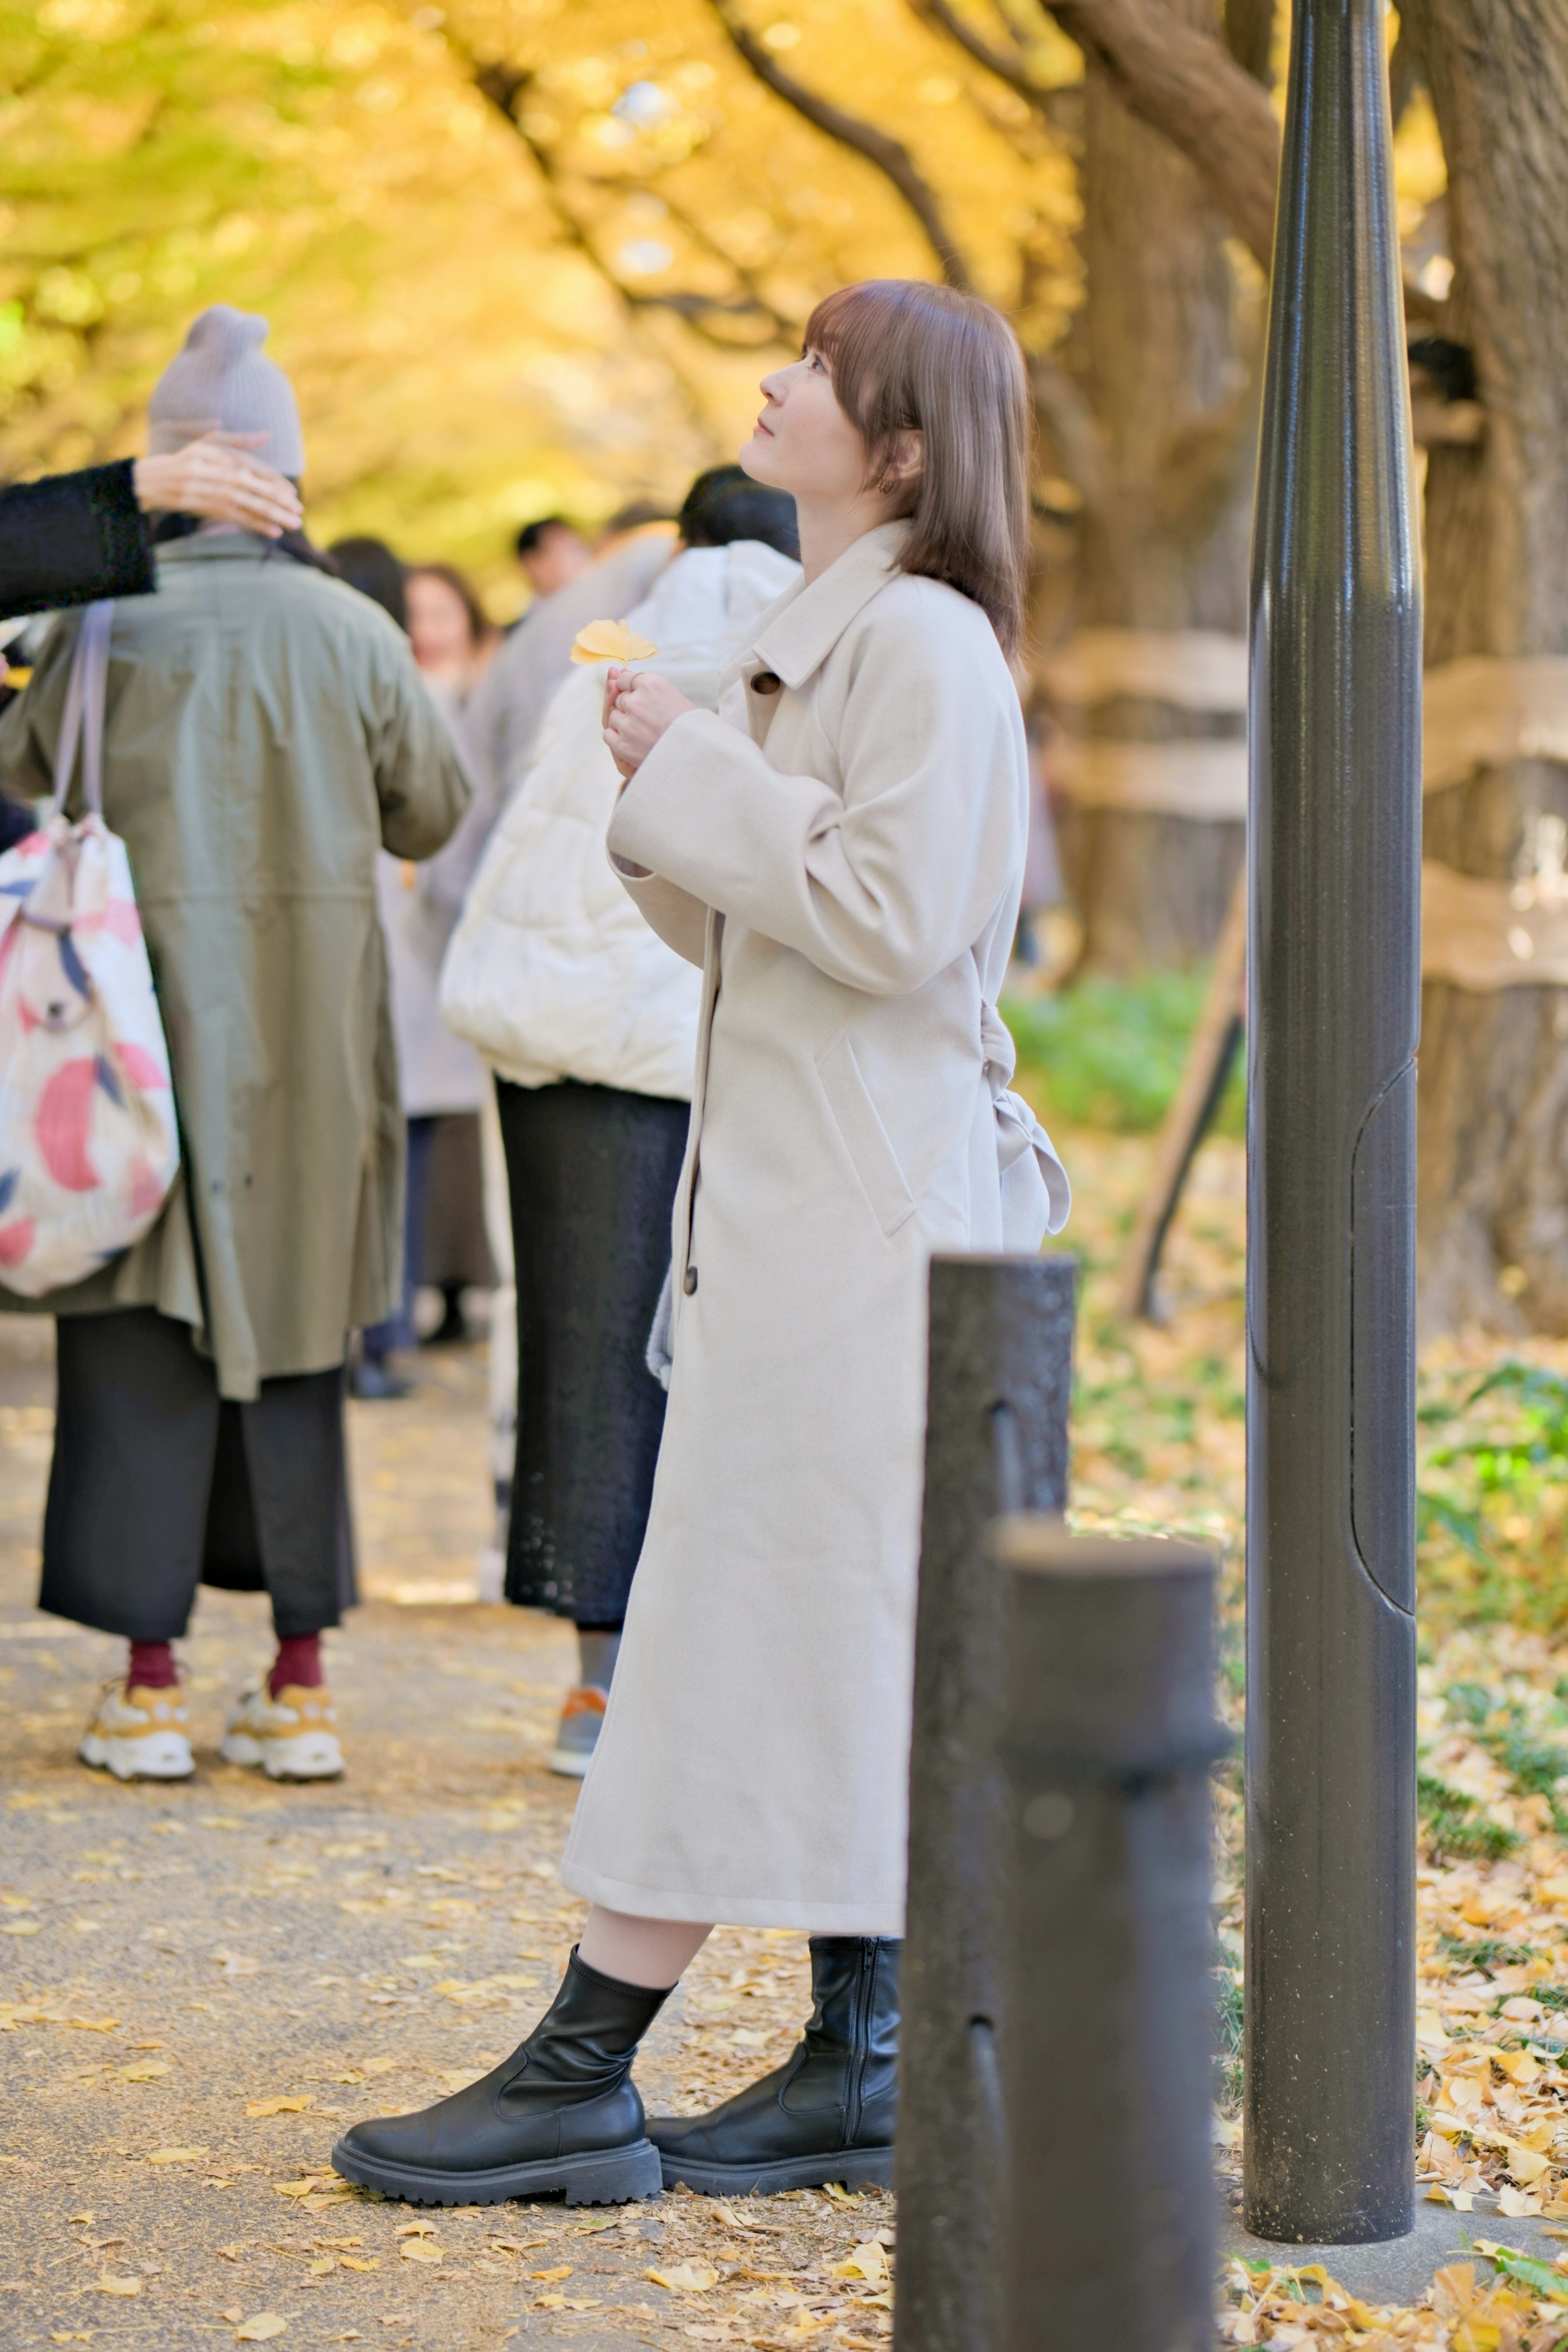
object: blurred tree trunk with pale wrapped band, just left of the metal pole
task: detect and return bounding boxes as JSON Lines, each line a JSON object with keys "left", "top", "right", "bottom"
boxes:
{"left": 1060, "top": 18, "right": 1253, "bottom": 974}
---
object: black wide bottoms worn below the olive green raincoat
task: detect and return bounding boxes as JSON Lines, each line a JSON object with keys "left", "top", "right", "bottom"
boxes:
{"left": 38, "top": 1308, "right": 355, "bottom": 1642}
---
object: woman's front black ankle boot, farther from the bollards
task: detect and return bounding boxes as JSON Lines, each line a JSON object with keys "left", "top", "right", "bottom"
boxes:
{"left": 332, "top": 1952, "right": 670, "bottom": 2204}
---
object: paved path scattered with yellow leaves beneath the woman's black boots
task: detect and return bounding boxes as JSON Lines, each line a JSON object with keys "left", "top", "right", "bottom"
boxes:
{"left": 0, "top": 1320, "right": 891, "bottom": 2352}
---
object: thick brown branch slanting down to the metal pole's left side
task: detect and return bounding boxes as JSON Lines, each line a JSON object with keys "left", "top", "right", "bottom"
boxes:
{"left": 1041, "top": 0, "right": 1279, "bottom": 270}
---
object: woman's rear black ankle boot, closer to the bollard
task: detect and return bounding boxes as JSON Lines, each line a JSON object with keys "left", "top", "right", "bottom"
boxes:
{"left": 649, "top": 1936, "right": 903, "bottom": 2197}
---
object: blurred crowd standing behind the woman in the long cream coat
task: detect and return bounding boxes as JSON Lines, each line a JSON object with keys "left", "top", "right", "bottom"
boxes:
{"left": 0, "top": 306, "right": 797, "bottom": 1778}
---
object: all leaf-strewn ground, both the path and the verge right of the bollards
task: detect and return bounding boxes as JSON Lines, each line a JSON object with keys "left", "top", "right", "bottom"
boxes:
{"left": 15, "top": 1049, "right": 1568, "bottom": 2352}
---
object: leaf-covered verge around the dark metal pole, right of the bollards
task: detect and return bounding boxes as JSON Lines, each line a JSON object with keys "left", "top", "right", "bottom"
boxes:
{"left": 1058, "top": 1131, "right": 1568, "bottom": 2352}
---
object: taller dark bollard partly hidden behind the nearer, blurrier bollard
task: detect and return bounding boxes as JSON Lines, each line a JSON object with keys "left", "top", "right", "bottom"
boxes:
{"left": 893, "top": 1256, "right": 1077, "bottom": 2352}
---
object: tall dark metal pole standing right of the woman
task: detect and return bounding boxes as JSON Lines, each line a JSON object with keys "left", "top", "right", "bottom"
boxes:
{"left": 1244, "top": 0, "right": 1420, "bottom": 2244}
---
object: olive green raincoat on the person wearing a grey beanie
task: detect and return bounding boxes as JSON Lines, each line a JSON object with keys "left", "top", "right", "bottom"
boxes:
{"left": 0, "top": 532, "right": 468, "bottom": 1397}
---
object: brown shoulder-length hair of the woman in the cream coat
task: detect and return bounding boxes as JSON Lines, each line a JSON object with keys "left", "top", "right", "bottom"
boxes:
{"left": 806, "top": 278, "right": 1030, "bottom": 661}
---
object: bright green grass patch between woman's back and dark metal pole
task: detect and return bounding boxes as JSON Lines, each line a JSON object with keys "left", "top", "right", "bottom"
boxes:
{"left": 1002, "top": 969, "right": 1246, "bottom": 1136}
